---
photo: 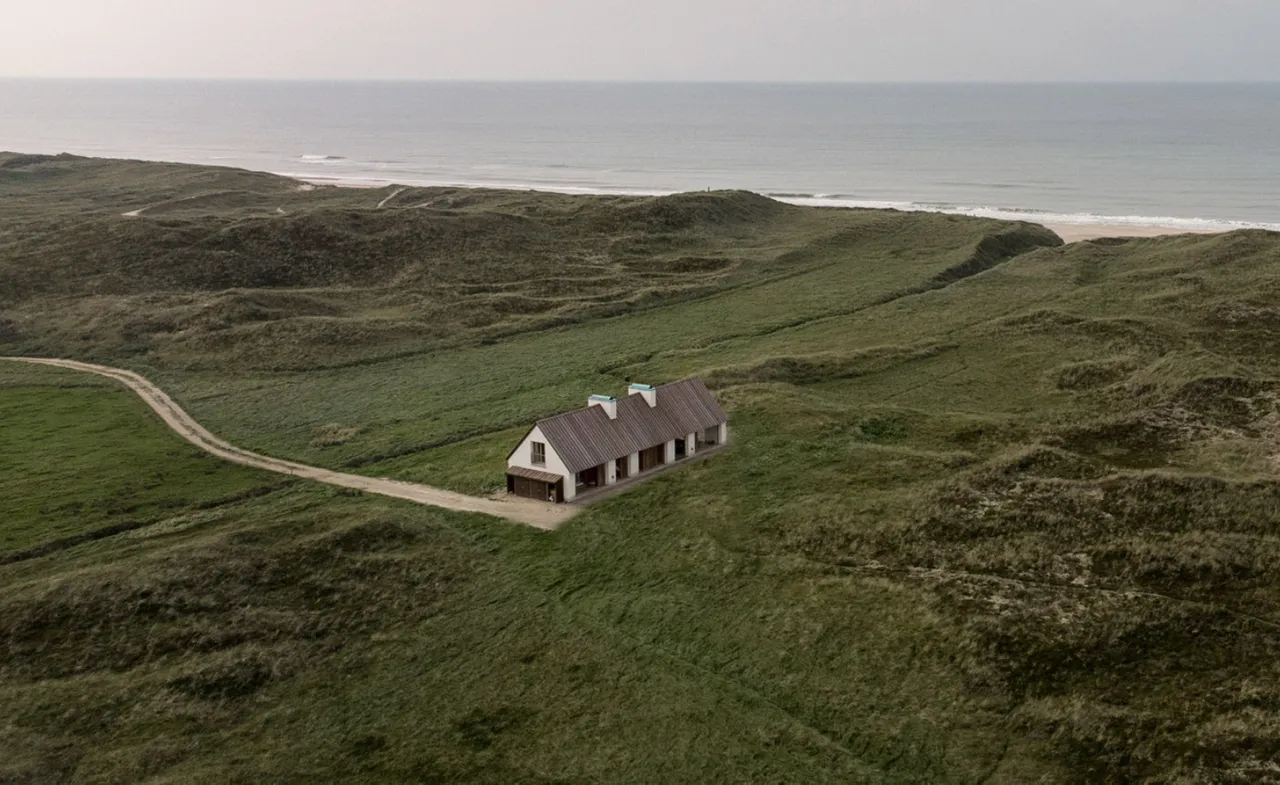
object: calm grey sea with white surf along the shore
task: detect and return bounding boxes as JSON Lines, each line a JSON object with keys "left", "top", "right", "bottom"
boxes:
{"left": 0, "top": 81, "right": 1280, "bottom": 229}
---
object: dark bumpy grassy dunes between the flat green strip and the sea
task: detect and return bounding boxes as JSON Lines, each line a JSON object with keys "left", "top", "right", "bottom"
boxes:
{"left": 0, "top": 160, "right": 1052, "bottom": 373}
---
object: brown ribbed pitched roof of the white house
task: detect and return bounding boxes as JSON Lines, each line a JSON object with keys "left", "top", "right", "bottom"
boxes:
{"left": 538, "top": 379, "right": 728, "bottom": 471}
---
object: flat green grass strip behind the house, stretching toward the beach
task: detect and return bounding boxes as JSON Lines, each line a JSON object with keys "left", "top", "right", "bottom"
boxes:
{"left": 147, "top": 214, "right": 1039, "bottom": 471}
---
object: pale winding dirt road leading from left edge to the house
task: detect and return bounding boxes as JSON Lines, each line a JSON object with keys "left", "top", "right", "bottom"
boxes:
{"left": 0, "top": 357, "right": 577, "bottom": 529}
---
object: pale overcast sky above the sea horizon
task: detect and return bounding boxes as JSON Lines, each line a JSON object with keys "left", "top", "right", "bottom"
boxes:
{"left": 10, "top": 0, "right": 1280, "bottom": 82}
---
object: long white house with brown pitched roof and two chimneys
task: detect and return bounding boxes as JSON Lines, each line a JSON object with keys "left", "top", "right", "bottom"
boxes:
{"left": 507, "top": 379, "right": 728, "bottom": 502}
